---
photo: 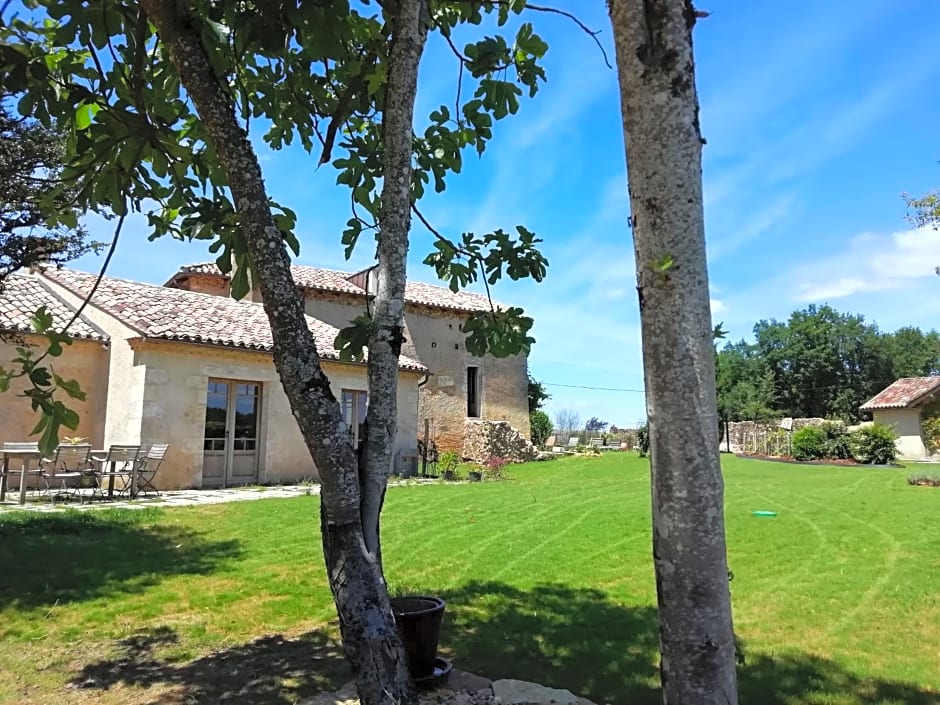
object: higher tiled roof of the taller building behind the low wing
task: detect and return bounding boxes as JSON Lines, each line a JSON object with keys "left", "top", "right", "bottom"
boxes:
{"left": 170, "top": 262, "right": 499, "bottom": 312}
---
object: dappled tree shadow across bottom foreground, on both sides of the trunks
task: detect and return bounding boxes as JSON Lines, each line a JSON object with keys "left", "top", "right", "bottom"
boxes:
{"left": 64, "top": 582, "right": 938, "bottom": 705}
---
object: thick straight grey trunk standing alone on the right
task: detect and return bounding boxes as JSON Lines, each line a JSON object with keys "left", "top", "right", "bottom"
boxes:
{"left": 609, "top": 0, "right": 737, "bottom": 705}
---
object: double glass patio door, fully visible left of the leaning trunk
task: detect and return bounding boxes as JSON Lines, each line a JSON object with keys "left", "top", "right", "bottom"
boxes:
{"left": 202, "top": 379, "right": 261, "bottom": 487}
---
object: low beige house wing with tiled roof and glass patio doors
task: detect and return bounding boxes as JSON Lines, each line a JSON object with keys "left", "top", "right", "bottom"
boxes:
{"left": 0, "top": 269, "right": 427, "bottom": 489}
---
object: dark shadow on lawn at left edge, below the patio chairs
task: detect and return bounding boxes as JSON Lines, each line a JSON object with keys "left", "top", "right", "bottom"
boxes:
{"left": 0, "top": 509, "right": 241, "bottom": 609}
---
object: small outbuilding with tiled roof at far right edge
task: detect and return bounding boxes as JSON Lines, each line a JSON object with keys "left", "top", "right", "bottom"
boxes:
{"left": 859, "top": 376, "right": 940, "bottom": 460}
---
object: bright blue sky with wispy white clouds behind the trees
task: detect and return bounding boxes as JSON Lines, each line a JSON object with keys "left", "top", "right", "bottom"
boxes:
{"left": 70, "top": 0, "right": 940, "bottom": 426}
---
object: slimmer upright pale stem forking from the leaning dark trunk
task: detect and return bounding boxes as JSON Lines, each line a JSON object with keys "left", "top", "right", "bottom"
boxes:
{"left": 360, "top": 0, "right": 427, "bottom": 568}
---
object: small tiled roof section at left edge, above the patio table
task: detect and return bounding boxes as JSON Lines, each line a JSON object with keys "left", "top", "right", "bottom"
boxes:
{"left": 0, "top": 274, "right": 108, "bottom": 340}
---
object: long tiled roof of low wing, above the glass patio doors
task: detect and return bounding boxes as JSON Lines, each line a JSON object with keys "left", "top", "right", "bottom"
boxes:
{"left": 45, "top": 269, "right": 427, "bottom": 372}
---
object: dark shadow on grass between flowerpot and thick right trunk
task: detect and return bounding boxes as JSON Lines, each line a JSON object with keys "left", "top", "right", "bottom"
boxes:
{"left": 441, "top": 582, "right": 662, "bottom": 704}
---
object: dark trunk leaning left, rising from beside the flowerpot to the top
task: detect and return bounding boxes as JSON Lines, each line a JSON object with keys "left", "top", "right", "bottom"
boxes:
{"left": 141, "top": 0, "right": 414, "bottom": 705}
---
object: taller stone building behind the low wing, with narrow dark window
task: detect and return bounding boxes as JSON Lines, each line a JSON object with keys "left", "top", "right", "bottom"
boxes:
{"left": 166, "top": 262, "right": 529, "bottom": 451}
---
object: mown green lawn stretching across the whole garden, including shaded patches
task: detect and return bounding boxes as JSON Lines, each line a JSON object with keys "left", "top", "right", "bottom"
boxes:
{"left": 0, "top": 454, "right": 940, "bottom": 705}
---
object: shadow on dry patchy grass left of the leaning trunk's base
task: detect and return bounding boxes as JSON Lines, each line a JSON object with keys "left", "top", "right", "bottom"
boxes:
{"left": 70, "top": 627, "right": 352, "bottom": 705}
